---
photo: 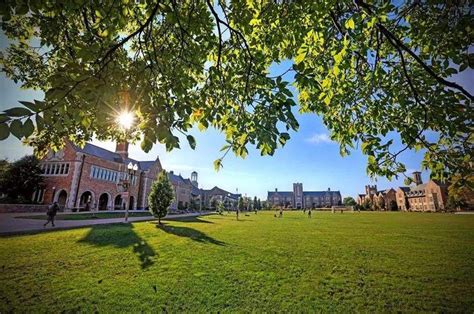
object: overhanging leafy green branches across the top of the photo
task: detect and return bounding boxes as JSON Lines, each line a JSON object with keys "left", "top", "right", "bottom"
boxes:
{"left": 0, "top": 0, "right": 474, "bottom": 191}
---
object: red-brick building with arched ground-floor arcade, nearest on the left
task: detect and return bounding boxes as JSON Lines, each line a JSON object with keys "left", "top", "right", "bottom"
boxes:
{"left": 33, "top": 141, "right": 162, "bottom": 210}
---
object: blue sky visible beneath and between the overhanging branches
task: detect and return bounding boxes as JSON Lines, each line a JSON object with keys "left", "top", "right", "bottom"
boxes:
{"left": 0, "top": 35, "right": 474, "bottom": 199}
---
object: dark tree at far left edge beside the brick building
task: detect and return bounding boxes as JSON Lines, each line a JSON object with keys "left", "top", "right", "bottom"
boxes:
{"left": 0, "top": 155, "right": 43, "bottom": 203}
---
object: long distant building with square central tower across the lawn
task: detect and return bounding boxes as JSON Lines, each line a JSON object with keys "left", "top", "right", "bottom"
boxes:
{"left": 267, "top": 183, "right": 342, "bottom": 209}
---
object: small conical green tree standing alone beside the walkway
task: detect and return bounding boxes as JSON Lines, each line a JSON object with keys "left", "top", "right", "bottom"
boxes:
{"left": 148, "top": 170, "right": 173, "bottom": 224}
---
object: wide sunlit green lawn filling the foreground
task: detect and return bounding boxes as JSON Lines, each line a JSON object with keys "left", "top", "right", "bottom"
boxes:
{"left": 0, "top": 212, "right": 474, "bottom": 313}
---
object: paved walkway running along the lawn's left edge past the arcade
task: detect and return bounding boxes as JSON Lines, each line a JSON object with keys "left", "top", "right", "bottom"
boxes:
{"left": 0, "top": 211, "right": 209, "bottom": 235}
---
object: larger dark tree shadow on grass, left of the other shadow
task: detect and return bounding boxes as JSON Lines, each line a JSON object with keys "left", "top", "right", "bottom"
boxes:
{"left": 79, "top": 223, "right": 157, "bottom": 269}
